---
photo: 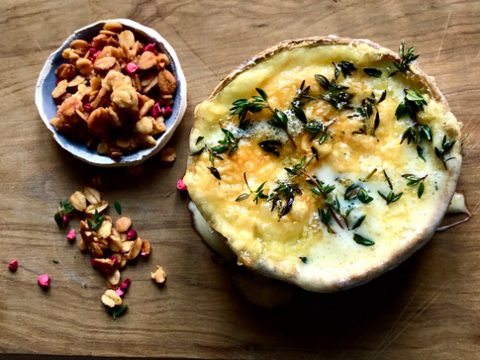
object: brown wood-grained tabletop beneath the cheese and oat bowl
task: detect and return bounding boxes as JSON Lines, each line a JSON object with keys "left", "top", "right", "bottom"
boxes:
{"left": 0, "top": 0, "right": 480, "bottom": 360}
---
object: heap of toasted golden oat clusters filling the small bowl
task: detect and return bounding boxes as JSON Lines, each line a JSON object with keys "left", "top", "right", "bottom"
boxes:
{"left": 50, "top": 22, "right": 177, "bottom": 158}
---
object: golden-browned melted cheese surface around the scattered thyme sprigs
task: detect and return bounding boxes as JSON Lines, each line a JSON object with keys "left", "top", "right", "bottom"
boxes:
{"left": 184, "top": 41, "right": 461, "bottom": 291}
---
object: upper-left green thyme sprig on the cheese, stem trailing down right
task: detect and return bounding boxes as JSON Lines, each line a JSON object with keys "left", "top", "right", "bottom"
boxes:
{"left": 230, "top": 88, "right": 297, "bottom": 149}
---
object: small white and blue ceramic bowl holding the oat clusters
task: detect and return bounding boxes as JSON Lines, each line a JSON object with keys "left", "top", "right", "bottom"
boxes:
{"left": 35, "top": 19, "right": 187, "bottom": 167}
